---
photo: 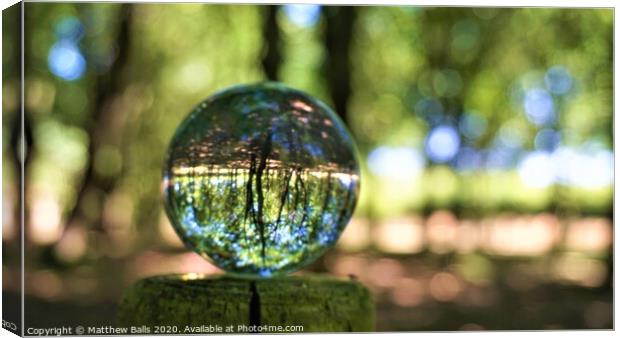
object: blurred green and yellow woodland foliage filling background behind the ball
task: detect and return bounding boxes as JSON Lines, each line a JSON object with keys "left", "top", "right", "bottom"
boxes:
{"left": 3, "top": 3, "right": 613, "bottom": 262}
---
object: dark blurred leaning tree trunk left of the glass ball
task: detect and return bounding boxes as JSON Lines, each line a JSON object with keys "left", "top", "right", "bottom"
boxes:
{"left": 67, "top": 4, "right": 133, "bottom": 226}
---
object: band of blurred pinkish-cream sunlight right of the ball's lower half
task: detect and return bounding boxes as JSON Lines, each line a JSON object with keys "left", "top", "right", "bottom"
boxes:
{"left": 338, "top": 210, "right": 612, "bottom": 257}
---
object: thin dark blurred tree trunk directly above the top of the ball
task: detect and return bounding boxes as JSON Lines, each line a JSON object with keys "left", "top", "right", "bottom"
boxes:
{"left": 262, "top": 5, "right": 282, "bottom": 81}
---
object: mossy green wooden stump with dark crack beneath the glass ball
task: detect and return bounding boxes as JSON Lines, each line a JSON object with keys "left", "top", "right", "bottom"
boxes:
{"left": 118, "top": 275, "right": 375, "bottom": 333}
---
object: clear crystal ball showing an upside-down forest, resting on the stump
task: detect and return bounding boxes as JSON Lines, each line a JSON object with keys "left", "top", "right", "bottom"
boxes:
{"left": 163, "top": 83, "right": 360, "bottom": 277}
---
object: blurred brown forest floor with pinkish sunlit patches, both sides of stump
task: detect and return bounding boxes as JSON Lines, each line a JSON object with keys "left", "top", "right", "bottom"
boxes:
{"left": 5, "top": 211, "right": 613, "bottom": 331}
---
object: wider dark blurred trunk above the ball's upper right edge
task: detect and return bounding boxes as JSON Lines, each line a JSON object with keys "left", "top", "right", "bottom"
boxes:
{"left": 323, "top": 6, "right": 356, "bottom": 125}
